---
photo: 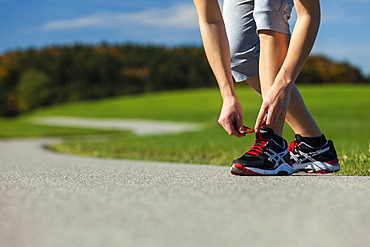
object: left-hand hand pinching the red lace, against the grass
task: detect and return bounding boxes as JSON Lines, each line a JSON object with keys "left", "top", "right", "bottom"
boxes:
{"left": 218, "top": 97, "right": 245, "bottom": 137}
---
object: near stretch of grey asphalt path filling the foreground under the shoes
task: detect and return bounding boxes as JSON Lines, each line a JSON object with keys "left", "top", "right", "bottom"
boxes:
{"left": 0, "top": 139, "right": 370, "bottom": 247}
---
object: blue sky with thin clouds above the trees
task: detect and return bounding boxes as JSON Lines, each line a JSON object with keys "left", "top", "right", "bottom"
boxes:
{"left": 0, "top": 0, "right": 370, "bottom": 75}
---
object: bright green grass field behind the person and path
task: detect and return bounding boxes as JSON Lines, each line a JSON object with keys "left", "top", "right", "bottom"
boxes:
{"left": 0, "top": 85, "right": 370, "bottom": 175}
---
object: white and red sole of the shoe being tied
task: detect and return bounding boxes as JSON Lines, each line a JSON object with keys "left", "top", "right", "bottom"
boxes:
{"left": 230, "top": 163, "right": 293, "bottom": 176}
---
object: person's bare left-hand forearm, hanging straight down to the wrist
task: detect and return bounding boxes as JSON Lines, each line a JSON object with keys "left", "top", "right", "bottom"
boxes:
{"left": 194, "top": 0, "right": 236, "bottom": 99}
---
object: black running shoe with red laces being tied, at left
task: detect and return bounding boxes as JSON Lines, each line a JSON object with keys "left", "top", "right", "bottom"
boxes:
{"left": 230, "top": 128, "right": 293, "bottom": 176}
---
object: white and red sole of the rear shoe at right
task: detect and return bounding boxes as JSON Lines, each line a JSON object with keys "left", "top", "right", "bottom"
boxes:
{"left": 293, "top": 161, "right": 340, "bottom": 174}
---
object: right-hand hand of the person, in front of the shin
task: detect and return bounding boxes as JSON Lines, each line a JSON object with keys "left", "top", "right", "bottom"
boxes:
{"left": 255, "top": 83, "right": 291, "bottom": 132}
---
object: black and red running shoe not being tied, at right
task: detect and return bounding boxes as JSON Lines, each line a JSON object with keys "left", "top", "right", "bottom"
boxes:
{"left": 289, "top": 135, "right": 340, "bottom": 173}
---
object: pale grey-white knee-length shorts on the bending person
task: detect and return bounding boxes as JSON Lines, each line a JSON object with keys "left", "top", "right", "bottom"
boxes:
{"left": 222, "top": 0, "right": 294, "bottom": 82}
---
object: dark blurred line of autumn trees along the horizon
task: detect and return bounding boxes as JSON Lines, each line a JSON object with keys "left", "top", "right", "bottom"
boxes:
{"left": 0, "top": 43, "right": 369, "bottom": 116}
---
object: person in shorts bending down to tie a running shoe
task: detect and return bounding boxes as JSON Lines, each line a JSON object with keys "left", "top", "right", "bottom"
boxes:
{"left": 194, "top": 0, "right": 340, "bottom": 175}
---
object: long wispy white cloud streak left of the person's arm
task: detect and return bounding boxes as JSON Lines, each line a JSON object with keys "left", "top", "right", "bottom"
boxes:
{"left": 41, "top": 3, "right": 198, "bottom": 31}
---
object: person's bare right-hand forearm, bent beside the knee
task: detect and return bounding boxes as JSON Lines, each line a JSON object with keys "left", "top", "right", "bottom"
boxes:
{"left": 277, "top": 0, "right": 320, "bottom": 86}
